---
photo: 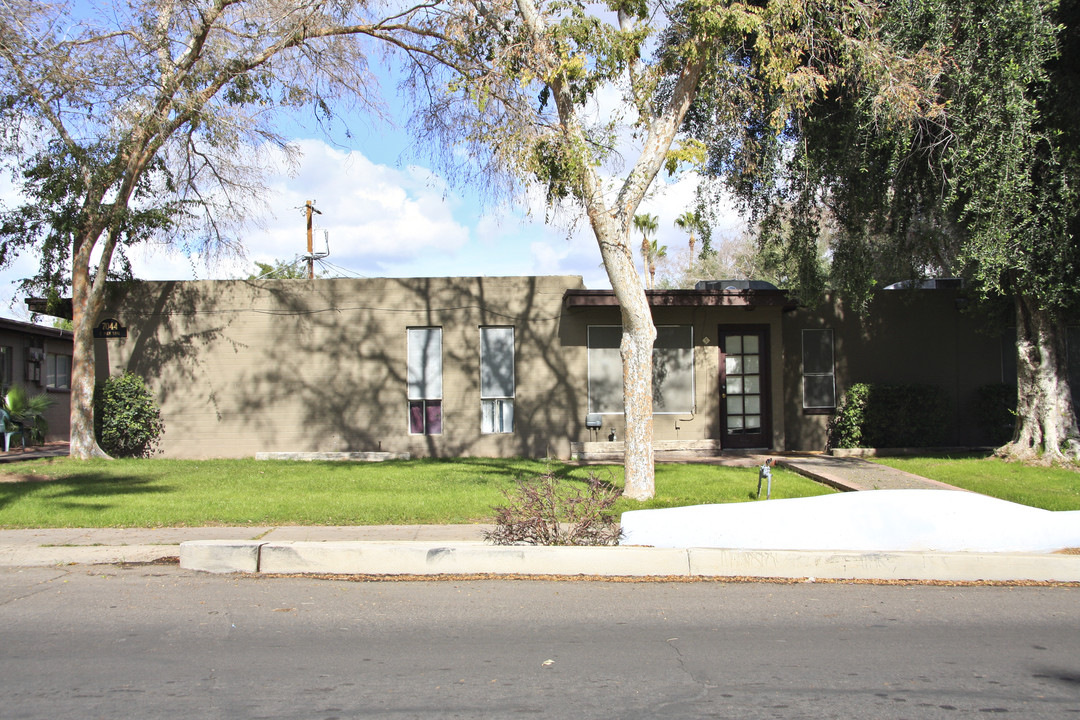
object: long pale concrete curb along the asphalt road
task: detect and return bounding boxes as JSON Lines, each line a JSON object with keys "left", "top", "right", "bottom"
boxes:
{"left": 180, "top": 541, "right": 1080, "bottom": 582}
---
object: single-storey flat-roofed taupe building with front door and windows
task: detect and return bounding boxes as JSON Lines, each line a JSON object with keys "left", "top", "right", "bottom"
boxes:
{"left": 95, "top": 276, "right": 1015, "bottom": 458}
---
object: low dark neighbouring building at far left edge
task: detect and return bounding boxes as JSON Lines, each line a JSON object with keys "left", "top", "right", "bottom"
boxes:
{"left": 0, "top": 317, "right": 71, "bottom": 442}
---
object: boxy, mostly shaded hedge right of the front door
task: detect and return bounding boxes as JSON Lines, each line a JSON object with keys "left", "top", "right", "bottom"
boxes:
{"left": 828, "top": 383, "right": 949, "bottom": 448}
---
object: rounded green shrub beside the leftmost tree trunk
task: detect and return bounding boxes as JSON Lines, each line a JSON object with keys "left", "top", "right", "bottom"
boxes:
{"left": 94, "top": 372, "right": 165, "bottom": 458}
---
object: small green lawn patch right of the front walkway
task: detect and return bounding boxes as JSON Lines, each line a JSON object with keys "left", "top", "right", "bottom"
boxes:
{"left": 872, "top": 456, "right": 1080, "bottom": 511}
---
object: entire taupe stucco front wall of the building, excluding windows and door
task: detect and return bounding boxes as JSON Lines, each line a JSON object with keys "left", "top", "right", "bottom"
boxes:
{"left": 103, "top": 276, "right": 1019, "bottom": 458}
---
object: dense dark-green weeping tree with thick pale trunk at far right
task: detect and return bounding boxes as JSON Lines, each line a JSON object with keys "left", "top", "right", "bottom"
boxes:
{"left": 694, "top": 0, "right": 1080, "bottom": 462}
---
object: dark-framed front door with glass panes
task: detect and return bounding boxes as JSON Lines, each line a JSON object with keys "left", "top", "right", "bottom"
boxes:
{"left": 719, "top": 326, "right": 772, "bottom": 448}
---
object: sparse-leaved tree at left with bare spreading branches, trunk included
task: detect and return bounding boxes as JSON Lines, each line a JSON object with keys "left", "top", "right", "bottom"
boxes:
{"left": 0, "top": 0, "right": 440, "bottom": 458}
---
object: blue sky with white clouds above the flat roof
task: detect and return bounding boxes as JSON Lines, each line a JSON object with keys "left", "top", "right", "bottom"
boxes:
{"left": 0, "top": 7, "right": 739, "bottom": 320}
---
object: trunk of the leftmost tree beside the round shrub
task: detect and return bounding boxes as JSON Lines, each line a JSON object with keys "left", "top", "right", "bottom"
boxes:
{"left": 70, "top": 237, "right": 109, "bottom": 460}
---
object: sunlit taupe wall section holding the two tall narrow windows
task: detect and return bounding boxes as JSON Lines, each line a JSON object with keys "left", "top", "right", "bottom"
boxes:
{"left": 97, "top": 276, "right": 585, "bottom": 458}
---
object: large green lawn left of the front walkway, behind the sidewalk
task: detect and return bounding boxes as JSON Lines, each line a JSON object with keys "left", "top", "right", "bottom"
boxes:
{"left": 0, "top": 458, "right": 832, "bottom": 528}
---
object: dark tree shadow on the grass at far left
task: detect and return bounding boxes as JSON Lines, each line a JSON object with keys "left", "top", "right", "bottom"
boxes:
{"left": 0, "top": 473, "right": 175, "bottom": 515}
